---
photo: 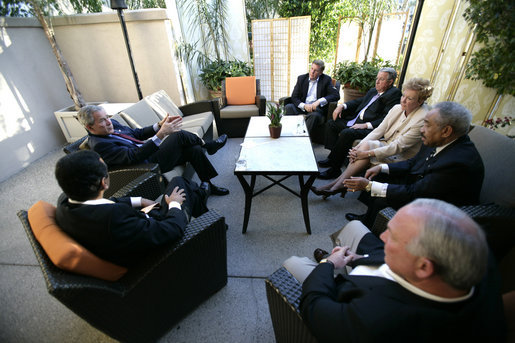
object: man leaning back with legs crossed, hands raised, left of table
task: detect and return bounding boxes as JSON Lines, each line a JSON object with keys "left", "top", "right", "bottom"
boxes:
{"left": 77, "top": 105, "right": 229, "bottom": 195}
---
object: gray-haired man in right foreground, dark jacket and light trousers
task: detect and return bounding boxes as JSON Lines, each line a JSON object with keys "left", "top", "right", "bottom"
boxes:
{"left": 284, "top": 199, "right": 506, "bottom": 343}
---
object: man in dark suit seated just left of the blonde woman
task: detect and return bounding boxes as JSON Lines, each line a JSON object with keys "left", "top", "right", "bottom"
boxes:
{"left": 318, "top": 68, "right": 402, "bottom": 180}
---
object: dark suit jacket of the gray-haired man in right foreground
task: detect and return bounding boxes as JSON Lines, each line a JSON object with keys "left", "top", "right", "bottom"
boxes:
{"left": 300, "top": 233, "right": 505, "bottom": 343}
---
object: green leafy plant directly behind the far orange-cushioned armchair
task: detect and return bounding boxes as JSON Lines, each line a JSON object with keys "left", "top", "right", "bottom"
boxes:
{"left": 199, "top": 60, "right": 252, "bottom": 91}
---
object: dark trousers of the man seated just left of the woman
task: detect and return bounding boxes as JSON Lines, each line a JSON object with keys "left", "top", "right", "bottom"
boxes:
{"left": 324, "top": 118, "right": 372, "bottom": 168}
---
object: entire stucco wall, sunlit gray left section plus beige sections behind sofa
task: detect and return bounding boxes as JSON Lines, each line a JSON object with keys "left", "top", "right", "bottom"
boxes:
{"left": 0, "top": 9, "right": 184, "bottom": 181}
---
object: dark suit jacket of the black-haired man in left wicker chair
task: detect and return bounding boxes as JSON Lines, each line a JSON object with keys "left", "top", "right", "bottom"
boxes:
{"left": 56, "top": 194, "right": 188, "bottom": 267}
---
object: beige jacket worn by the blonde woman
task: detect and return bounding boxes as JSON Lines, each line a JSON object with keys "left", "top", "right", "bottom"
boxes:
{"left": 360, "top": 104, "right": 429, "bottom": 161}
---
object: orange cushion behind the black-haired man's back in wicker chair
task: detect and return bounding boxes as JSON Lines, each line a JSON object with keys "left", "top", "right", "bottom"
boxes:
{"left": 28, "top": 200, "right": 127, "bottom": 281}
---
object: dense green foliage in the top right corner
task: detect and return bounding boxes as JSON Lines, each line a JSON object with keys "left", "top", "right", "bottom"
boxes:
{"left": 463, "top": 0, "right": 515, "bottom": 96}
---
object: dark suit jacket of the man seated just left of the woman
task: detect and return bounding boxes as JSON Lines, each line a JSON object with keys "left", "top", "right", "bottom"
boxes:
{"left": 342, "top": 87, "right": 402, "bottom": 128}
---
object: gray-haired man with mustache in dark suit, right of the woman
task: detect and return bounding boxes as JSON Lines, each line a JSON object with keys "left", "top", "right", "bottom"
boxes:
{"left": 342, "top": 102, "right": 484, "bottom": 227}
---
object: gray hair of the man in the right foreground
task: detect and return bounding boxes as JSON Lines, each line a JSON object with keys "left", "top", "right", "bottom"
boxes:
{"left": 406, "top": 199, "right": 488, "bottom": 290}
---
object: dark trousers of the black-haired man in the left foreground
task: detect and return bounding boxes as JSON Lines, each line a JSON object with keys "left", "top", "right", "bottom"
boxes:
{"left": 160, "top": 176, "right": 208, "bottom": 218}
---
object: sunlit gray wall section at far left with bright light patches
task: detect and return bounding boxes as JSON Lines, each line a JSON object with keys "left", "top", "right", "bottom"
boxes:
{"left": 0, "top": 18, "right": 71, "bottom": 181}
